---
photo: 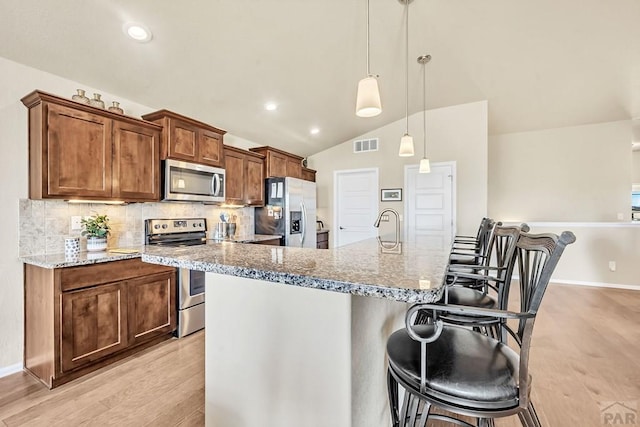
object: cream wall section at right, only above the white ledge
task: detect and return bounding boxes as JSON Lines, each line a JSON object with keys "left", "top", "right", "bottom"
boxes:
{"left": 489, "top": 120, "right": 631, "bottom": 221}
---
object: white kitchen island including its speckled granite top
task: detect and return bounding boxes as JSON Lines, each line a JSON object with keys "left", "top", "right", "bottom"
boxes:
{"left": 142, "top": 239, "right": 447, "bottom": 427}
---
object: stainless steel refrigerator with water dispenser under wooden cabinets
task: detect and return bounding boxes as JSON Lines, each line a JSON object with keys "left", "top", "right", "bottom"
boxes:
{"left": 255, "top": 177, "right": 316, "bottom": 248}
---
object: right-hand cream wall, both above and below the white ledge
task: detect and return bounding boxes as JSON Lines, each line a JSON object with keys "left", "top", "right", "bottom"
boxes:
{"left": 489, "top": 120, "right": 640, "bottom": 289}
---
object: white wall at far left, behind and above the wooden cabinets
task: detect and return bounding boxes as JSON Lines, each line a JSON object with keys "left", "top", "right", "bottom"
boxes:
{"left": 0, "top": 57, "right": 258, "bottom": 376}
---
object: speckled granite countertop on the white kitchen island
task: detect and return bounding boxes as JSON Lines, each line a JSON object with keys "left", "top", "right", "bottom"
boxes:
{"left": 142, "top": 239, "right": 448, "bottom": 303}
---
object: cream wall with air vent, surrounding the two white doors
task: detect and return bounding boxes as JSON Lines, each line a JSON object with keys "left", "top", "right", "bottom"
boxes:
{"left": 308, "top": 101, "right": 488, "bottom": 241}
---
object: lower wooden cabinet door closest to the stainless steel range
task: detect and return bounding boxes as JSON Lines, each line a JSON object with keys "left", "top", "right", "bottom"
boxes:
{"left": 127, "top": 272, "right": 176, "bottom": 345}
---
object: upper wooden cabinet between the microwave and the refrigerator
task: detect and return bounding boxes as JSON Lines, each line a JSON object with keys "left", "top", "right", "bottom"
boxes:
{"left": 224, "top": 146, "right": 264, "bottom": 206}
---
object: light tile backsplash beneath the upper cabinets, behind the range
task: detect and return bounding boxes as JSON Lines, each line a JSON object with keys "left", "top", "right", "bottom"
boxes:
{"left": 20, "top": 199, "right": 255, "bottom": 256}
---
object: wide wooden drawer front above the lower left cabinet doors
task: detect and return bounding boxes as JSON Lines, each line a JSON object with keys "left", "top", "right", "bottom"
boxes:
{"left": 60, "top": 258, "right": 175, "bottom": 292}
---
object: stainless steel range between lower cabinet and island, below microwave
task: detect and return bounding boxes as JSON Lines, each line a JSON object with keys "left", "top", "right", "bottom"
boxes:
{"left": 145, "top": 218, "right": 207, "bottom": 337}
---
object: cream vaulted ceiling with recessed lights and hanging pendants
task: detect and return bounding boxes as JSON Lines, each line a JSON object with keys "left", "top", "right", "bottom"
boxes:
{"left": 0, "top": 0, "right": 640, "bottom": 155}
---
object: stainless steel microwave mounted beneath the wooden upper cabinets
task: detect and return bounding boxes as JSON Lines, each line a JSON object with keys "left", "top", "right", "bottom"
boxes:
{"left": 164, "top": 159, "right": 225, "bottom": 203}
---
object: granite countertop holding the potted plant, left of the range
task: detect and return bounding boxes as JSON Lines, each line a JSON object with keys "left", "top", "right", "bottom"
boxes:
{"left": 20, "top": 246, "right": 144, "bottom": 268}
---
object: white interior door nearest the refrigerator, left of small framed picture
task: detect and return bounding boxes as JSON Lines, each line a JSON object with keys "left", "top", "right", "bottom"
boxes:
{"left": 333, "top": 169, "right": 378, "bottom": 247}
